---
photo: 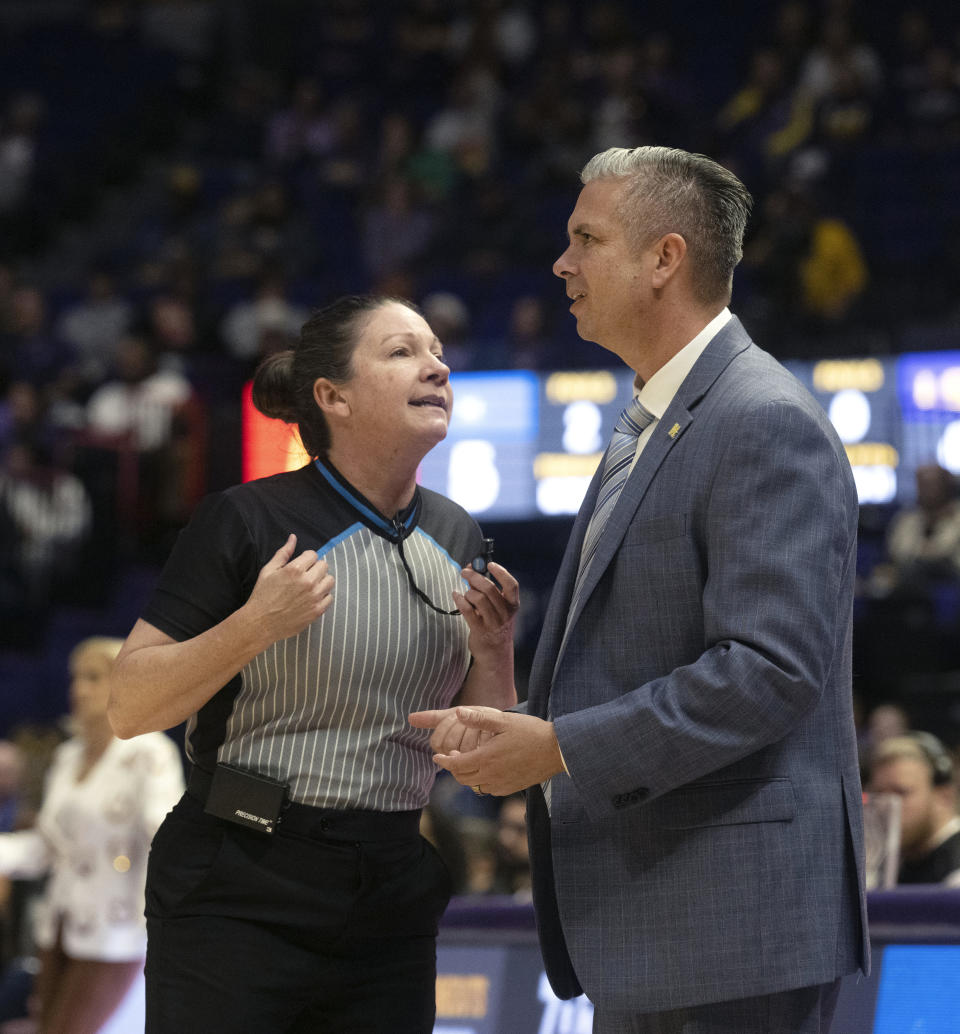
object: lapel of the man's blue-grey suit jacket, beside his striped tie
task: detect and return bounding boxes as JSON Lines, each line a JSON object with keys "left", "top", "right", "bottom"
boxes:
{"left": 531, "top": 316, "right": 751, "bottom": 686}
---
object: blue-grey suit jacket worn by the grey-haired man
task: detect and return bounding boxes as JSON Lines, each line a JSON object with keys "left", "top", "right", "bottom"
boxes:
{"left": 527, "top": 317, "right": 869, "bottom": 1011}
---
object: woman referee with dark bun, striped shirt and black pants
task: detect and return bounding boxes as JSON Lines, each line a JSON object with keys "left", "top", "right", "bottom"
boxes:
{"left": 104, "top": 296, "right": 518, "bottom": 1034}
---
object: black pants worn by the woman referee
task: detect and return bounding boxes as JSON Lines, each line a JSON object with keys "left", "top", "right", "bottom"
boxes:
{"left": 146, "top": 793, "right": 450, "bottom": 1034}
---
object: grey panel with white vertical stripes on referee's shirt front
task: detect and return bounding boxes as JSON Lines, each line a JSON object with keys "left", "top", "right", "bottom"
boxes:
{"left": 219, "top": 523, "right": 470, "bottom": 811}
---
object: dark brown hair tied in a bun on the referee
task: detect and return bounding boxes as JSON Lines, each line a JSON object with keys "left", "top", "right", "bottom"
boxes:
{"left": 253, "top": 295, "right": 420, "bottom": 457}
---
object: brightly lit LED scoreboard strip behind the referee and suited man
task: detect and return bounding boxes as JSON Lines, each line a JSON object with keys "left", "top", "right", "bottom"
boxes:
{"left": 243, "top": 352, "right": 960, "bottom": 510}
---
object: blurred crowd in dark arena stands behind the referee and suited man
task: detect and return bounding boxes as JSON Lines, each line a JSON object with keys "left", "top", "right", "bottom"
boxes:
{"left": 0, "top": 0, "right": 960, "bottom": 1021}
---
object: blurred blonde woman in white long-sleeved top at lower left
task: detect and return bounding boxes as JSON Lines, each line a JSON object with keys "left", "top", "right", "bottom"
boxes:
{"left": 0, "top": 638, "right": 183, "bottom": 1034}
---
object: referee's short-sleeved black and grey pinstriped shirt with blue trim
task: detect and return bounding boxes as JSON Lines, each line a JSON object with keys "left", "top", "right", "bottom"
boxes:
{"left": 143, "top": 461, "right": 481, "bottom": 812}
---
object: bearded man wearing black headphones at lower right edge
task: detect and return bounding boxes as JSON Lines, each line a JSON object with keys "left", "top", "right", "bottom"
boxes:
{"left": 868, "top": 732, "right": 960, "bottom": 886}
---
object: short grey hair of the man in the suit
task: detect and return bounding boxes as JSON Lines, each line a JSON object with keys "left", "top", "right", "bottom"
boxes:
{"left": 580, "top": 147, "right": 753, "bottom": 304}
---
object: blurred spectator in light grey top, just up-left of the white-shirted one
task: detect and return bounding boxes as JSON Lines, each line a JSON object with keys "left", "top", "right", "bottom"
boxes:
{"left": 57, "top": 268, "right": 134, "bottom": 385}
